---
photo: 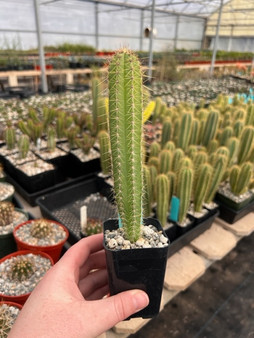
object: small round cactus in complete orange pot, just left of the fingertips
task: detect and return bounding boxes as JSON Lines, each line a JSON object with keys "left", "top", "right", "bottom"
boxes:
{"left": 13, "top": 219, "right": 69, "bottom": 263}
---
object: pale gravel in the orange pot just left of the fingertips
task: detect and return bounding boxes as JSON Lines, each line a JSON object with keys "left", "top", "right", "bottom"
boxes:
{"left": 15, "top": 222, "right": 66, "bottom": 246}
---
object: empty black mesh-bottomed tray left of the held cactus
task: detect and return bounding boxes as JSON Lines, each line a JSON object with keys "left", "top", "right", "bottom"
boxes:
{"left": 36, "top": 176, "right": 117, "bottom": 244}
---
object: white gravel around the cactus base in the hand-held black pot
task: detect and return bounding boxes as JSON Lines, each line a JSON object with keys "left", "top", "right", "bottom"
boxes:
{"left": 105, "top": 224, "right": 168, "bottom": 250}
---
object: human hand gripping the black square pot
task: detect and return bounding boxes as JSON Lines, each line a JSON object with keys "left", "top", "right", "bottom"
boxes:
{"left": 8, "top": 234, "right": 149, "bottom": 338}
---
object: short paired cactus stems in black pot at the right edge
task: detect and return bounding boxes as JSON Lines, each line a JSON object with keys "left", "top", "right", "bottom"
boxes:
{"left": 229, "top": 162, "right": 253, "bottom": 196}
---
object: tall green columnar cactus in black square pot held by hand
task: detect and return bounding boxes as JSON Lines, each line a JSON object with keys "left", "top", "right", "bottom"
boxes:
{"left": 104, "top": 50, "right": 168, "bottom": 318}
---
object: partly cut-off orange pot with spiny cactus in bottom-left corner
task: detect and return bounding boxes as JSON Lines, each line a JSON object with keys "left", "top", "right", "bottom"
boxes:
{"left": 0, "top": 301, "right": 22, "bottom": 338}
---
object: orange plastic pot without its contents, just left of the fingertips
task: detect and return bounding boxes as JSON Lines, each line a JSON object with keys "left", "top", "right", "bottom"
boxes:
{"left": 13, "top": 220, "right": 69, "bottom": 263}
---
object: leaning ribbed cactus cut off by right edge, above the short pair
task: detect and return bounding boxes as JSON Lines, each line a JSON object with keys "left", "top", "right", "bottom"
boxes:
{"left": 237, "top": 126, "right": 254, "bottom": 164}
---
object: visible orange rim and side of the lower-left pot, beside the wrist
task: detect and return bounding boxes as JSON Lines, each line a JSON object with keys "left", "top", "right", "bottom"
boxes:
{"left": 0, "top": 250, "right": 54, "bottom": 305}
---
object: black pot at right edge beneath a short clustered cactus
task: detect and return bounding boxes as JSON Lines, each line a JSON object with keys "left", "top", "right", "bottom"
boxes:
{"left": 216, "top": 200, "right": 254, "bottom": 224}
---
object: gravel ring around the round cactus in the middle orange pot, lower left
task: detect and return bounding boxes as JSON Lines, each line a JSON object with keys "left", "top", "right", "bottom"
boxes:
{"left": 0, "top": 253, "right": 51, "bottom": 296}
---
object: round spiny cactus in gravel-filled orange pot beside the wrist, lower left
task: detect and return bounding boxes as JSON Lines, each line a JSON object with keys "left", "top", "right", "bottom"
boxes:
{"left": 0, "top": 250, "right": 53, "bottom": 305}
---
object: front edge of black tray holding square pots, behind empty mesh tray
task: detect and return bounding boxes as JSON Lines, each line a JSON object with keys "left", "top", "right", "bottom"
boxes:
{"left": 6, "top": 175, "right": 95, "bottom": 207}
